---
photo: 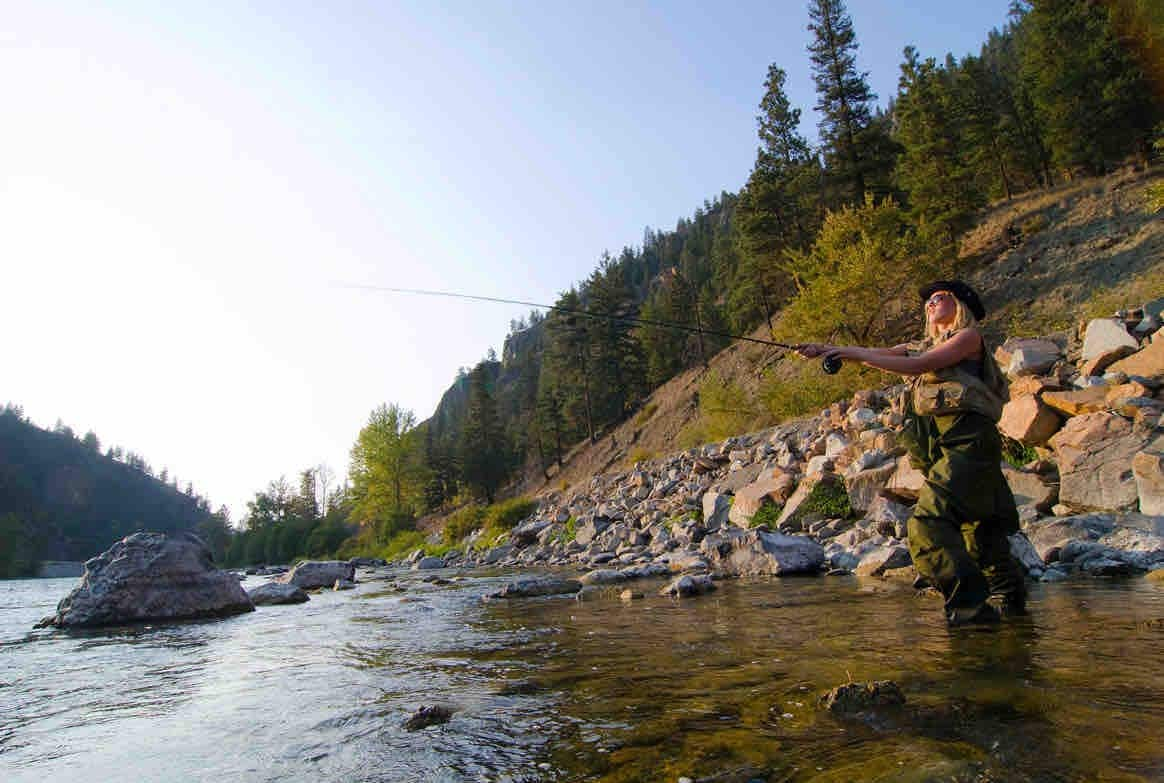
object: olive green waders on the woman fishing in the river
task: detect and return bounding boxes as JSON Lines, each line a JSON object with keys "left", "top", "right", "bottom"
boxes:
{"left": 904, "top": 412, "right": 1025, "bottom": 613}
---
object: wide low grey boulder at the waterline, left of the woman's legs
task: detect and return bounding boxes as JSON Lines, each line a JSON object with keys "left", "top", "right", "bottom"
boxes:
{"left": 700, "top": 528, "right": 824, "bottom": 576}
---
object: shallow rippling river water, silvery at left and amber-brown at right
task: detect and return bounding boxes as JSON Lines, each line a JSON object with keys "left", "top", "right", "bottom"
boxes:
{"left": 0, "top": 572, "right": 1164, "bottom": 783}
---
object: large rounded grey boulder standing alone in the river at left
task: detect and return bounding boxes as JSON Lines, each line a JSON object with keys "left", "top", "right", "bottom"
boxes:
{"left": 37, "top": 533, "right": 255, "bottom": 628}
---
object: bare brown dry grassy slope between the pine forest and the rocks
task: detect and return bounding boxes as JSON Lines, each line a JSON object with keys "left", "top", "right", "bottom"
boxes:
{"left": 521, "top": 168, "right": 1164, "bottom": 493}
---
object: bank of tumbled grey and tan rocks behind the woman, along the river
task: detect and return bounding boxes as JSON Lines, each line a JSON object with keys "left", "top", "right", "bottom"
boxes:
{"left": 409, "top": 299, "right": 1164, "bottom": 593}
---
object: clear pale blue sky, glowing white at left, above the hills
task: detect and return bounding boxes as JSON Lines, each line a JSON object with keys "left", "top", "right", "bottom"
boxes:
{"left": 0, "top": 0, "right": 1008, "bottom": 520}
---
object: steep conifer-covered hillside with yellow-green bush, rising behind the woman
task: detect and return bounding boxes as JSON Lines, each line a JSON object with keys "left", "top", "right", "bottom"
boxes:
{"left": 407, "top": 0, "right": 1164, "bottom": 524}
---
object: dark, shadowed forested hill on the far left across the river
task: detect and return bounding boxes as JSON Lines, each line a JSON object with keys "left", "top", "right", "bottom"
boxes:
{"left": 0, "top": 406, "right": 211, "bottom": 577}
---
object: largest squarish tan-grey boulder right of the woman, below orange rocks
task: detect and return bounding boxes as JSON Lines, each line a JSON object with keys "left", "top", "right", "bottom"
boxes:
{"left": 1050, "top": 412, "right": 1164, "bottom": 511}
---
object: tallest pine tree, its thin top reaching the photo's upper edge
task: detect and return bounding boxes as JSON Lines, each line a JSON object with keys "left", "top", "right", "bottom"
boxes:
{"left": 808, "top": 0, "right": 876, "bottom": 202}
